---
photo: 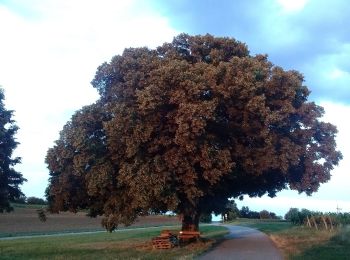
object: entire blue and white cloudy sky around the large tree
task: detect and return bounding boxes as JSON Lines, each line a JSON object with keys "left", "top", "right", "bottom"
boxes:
{"left": 0, "top": 0, "right": 350, "bottom": 214}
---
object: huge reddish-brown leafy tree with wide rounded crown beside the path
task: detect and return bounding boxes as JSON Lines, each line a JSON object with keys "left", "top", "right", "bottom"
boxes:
{"left": 46, "top": 34, "right": 341, "bottom": 230}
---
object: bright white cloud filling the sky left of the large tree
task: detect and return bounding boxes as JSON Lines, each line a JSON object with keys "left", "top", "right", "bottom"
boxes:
{"left": 0, "top": 0, "right": 177, "bottom": 196}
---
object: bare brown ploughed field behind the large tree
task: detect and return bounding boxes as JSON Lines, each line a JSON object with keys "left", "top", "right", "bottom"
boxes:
{"left": 0, "top": 208, "right": 180, "bottom": 236}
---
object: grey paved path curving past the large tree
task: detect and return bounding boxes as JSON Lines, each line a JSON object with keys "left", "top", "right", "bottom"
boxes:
{"left": 199, "top": 225, "right": 283, "bottom": 260}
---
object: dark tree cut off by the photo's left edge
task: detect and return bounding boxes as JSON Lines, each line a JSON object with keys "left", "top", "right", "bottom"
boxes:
{"left": 0, "top": 88, "right": 26, "bottom": 213}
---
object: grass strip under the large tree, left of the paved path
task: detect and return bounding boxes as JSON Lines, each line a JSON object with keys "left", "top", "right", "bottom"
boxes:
{"left": 0, "top": 226, "right": 227, "bottom": 259}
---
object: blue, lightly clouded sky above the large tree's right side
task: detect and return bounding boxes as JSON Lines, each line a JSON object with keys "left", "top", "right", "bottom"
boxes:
{"left": 154, "top": 0, "right": 350, "bottom": 103}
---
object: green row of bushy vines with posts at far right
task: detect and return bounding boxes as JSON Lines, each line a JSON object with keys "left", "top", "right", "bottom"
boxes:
{"left": 284, "top": 208, "right": 350, "bottom": 225}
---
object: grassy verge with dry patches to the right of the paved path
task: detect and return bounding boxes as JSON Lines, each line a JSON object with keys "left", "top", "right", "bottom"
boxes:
{"left": 234, "top": 220, "right": 350, "bottom": 260}
